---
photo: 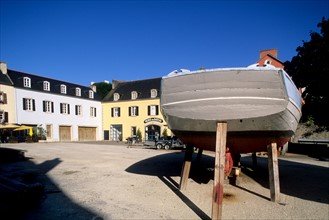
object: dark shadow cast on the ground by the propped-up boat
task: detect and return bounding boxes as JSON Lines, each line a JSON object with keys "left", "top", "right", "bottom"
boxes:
{"left": 126, "top": 152, "right": 329, "bottom": 211}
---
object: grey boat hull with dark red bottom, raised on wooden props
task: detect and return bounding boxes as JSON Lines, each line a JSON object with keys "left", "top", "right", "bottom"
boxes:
{"left": 160, "top": 65, "right": 302, "bottom": 153}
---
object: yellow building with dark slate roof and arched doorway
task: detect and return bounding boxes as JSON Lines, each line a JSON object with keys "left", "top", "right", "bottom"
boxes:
{"left": 102, "top": 78, "right": 172, "bottom": 141}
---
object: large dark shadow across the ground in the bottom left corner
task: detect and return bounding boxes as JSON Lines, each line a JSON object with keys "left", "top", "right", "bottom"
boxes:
{"left": 0, "top": 148, "right": 102, "bottom": 220}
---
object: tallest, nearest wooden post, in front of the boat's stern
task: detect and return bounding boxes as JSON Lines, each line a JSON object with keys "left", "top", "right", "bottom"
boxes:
{"left": 211, "top": 122, "right": 227, "bottom": 219}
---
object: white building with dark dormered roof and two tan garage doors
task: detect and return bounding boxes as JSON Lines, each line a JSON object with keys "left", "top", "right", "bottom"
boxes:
{"left": 3, "top": 63, "right": 102, "bottom": 142}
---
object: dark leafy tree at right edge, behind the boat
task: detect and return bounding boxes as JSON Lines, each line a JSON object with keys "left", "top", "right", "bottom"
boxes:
{"left": 284, "top": 18, "right": 329, "bottom": 128}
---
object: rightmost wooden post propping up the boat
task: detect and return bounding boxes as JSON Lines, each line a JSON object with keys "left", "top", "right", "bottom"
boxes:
{"left": 267, "top": 143, "right": 280, "bottom": 202}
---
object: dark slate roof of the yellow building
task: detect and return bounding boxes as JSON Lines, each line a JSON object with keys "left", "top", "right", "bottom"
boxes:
{"left": 103, "top": 78, "right": 161, "bottom": 102}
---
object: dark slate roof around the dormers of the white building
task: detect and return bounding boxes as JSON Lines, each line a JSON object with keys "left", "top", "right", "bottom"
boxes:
{"left": 8, "top": 69, "right": 101, "bottom": 101}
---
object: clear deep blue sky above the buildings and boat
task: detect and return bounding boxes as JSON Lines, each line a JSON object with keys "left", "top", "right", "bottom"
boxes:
{"left": 0, "top": 0, "right": 329, "bottom": 85}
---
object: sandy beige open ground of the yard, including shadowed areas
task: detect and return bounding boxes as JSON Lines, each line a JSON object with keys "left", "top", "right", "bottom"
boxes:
{"left": 0, "top": 142, "right": 329, "bottom": 219}
